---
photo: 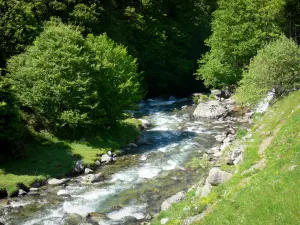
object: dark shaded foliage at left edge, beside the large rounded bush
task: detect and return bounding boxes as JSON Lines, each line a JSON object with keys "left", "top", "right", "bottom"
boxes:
{"left": 0, "top": 76, "right": 22, "bottom": 159}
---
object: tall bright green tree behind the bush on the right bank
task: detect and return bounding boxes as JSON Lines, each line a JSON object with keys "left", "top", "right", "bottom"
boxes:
{"left": 196, "top": 0, "right": 285, "bottom": 87}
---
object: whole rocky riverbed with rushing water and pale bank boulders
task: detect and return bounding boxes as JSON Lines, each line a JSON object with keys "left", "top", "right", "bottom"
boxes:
{"left": 0, "top": 98, "right": 248, "bottom": 225}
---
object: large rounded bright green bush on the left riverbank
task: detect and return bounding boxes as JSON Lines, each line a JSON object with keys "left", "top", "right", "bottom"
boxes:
{"left": 8, "top": 20, "right": 142, "bottom": 131}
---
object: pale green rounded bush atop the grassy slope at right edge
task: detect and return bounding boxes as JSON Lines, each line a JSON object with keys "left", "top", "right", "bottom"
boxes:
{"left": 235, "top": 36, "right": 300, "bottom": 106}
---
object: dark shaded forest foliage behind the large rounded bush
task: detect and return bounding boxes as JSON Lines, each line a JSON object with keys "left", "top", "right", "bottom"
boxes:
{"left": 0, "top": 0, "right": 216, "bottom": 94}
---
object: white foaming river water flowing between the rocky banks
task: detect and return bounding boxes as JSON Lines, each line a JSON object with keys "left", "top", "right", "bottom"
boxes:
{"left": 1, "top": 100, "right": 240, "bottom": 225}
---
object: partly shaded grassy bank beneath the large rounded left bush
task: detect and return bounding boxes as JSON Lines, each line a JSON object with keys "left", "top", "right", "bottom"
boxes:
{"left": 0, "top": 119, "right": 139, "bottom": 194}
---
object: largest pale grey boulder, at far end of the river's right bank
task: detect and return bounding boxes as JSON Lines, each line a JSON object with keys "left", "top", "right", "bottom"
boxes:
{"left": 193, "top": 101, "right": 229, "bottom": 118}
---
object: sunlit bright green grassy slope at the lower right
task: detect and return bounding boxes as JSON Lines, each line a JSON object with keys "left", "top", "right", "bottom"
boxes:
{"left": 153, "top": 91, "right": 300, "bottom": 225}
